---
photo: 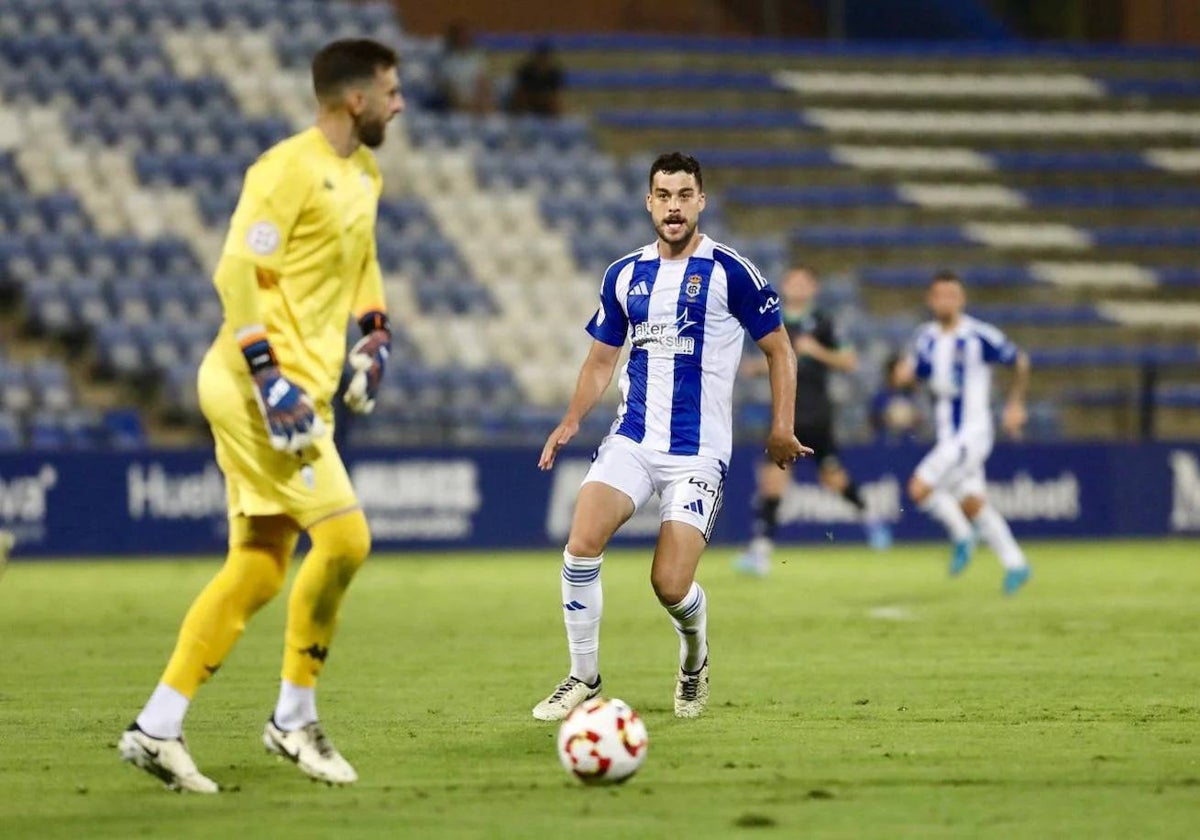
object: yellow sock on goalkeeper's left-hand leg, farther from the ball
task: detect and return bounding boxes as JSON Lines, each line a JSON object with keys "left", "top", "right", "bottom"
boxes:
{"left": 162, "top": 516, "right": 299, "bottom": 698}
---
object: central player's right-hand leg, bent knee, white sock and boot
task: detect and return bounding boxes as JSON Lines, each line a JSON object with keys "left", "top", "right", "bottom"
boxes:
{"left": 650, "top": 520, "right": 705, "bottom": 718}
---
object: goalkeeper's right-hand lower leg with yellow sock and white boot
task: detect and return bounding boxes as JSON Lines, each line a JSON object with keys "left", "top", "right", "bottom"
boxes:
{"left": 263, "top": 508, "right": 371, "bottom": 785}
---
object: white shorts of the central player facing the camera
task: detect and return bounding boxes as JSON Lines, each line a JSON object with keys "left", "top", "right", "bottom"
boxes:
{"left": 583, "top": 434, "right": 727, "bottom": 541}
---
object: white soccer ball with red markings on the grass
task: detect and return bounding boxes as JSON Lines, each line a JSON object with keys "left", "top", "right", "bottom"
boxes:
{"left": 558, "top": 697, "right": 647, "bottom": 785}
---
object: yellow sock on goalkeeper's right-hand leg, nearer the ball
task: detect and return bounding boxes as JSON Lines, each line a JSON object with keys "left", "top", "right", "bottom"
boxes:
{"left": 281, "top": 510, "right": 371, "bottom": 702}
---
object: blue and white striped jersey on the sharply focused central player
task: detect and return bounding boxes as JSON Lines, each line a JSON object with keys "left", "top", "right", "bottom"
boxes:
{"left": 588, "top": 236, "right": 782, "bottom": 463}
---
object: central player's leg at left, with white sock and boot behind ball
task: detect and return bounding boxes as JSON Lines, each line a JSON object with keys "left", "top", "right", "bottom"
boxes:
{"left": 533, "top": 481, "right": 634, "bottom": 720}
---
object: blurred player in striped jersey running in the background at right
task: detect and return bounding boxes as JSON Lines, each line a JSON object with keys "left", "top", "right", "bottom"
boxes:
{"left": 898, "top": 271, "right": 1030, "bottom": 595}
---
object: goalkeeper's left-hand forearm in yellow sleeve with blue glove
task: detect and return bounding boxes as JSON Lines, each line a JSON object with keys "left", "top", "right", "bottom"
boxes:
{"left": 214, "top": 254, "right": 324, "bottom": 452}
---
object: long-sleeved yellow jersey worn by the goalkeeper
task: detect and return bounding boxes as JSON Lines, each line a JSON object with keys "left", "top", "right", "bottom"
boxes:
{"left": 210, "top": 127, "right": 385, "bottom": 413}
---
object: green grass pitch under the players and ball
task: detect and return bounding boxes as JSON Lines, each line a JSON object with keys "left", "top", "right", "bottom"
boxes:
{"left": 0, "top": 541, "right": 1200, "bottom": 840}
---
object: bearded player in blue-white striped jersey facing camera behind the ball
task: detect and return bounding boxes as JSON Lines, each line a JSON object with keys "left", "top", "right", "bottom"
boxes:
{"left": 533, "top": 152, "right": 811, "bottom": 720}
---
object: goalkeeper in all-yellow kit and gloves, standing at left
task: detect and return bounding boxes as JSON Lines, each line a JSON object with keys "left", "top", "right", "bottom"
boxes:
{"left": 119, "top": 40, "right": 403, "bottom": 793}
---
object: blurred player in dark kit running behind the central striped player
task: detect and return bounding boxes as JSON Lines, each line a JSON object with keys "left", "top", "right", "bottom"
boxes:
{"left": 737, "top": 265, "right": 892, "bottom": 575}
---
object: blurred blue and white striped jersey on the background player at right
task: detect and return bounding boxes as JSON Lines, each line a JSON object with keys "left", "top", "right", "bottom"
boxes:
{"left": 912, "top": 316, "right": 1018, "bottom": 440}
